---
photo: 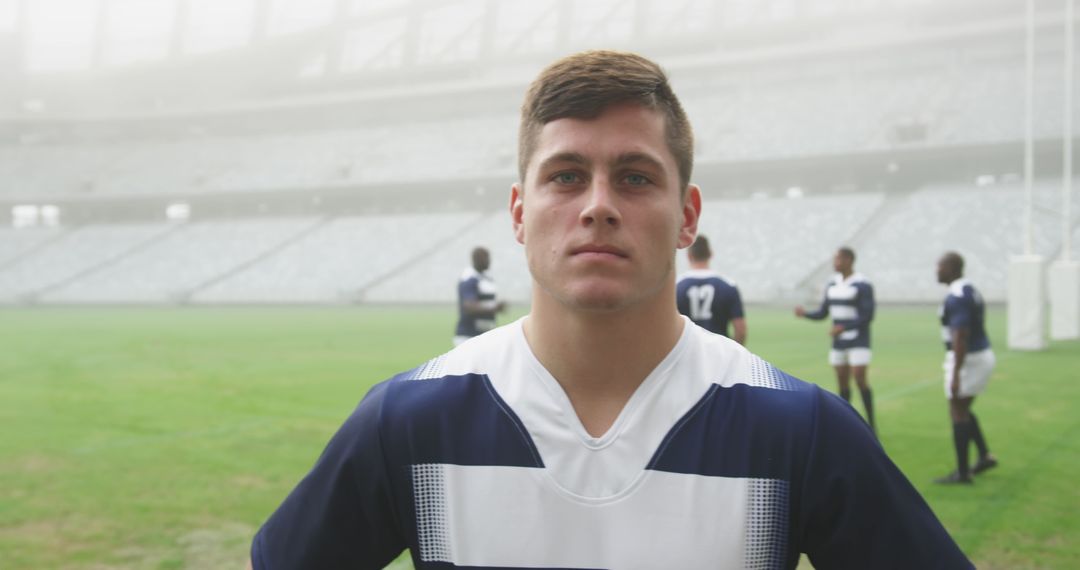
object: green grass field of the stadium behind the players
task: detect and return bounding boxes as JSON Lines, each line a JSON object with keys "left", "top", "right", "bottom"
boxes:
{"left": 0, "top": 307, "right": 1080, "bottom": 569}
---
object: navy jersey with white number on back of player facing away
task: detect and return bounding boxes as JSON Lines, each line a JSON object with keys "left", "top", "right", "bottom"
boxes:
{"left": 675, "top": 269, "right": 743, "bottom": 337}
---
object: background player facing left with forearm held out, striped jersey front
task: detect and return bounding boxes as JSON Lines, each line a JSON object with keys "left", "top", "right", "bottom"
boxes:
{"left": 795, "top": 247, "right": 877, "bottom": 433}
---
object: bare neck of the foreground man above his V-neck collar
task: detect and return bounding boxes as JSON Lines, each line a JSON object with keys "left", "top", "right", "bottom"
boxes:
{"left": 524, "top": 280, "right": 684, "bottom": 436}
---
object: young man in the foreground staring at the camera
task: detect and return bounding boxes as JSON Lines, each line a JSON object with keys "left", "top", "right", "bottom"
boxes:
{"left": 252, "top": 52, "right": 971, "bottom": 570}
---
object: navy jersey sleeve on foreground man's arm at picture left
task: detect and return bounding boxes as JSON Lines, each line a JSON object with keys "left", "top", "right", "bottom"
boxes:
{"left": 252, "top": 382, "right": 405, "bottom": 570}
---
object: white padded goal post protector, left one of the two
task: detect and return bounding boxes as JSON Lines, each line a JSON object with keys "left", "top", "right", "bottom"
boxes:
{"left": 1005, "top": 255, "right": 1047, "bottom": 350}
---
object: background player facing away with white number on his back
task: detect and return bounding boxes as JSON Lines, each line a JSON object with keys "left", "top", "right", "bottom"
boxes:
{"left": 675, "top": 235, "right": 746, "bottom": 345}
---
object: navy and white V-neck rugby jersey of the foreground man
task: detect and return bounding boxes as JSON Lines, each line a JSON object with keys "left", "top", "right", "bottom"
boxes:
{"left": 252, "top": 320, "right": 971, "bottom": 570}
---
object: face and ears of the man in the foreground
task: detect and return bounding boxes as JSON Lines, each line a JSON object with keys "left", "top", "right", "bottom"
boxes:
{"left": 511, "top": 104, "right": 701, "bottom": 311}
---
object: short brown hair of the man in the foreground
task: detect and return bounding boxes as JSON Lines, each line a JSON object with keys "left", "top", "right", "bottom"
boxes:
{"left": 517, "top": 50, "right": 693, "bottom": 191}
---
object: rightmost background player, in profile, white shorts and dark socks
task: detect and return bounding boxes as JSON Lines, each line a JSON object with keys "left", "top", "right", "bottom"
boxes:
{"left": 934, "top": 252, "right": 998, "bottom": 484}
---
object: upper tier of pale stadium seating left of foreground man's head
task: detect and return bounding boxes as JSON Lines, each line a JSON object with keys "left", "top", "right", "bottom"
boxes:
{"left": 0, "top": 116, "right": 516, "bottom": 196}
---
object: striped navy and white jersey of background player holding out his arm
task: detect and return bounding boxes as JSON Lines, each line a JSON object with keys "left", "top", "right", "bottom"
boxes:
{"left": 806, "top": 273, "right": 874, "bottom": 350}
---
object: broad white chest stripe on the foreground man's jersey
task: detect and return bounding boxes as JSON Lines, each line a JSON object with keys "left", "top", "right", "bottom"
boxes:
{"left": 414, "top": 464, "right": 786, "bottom": 569}
